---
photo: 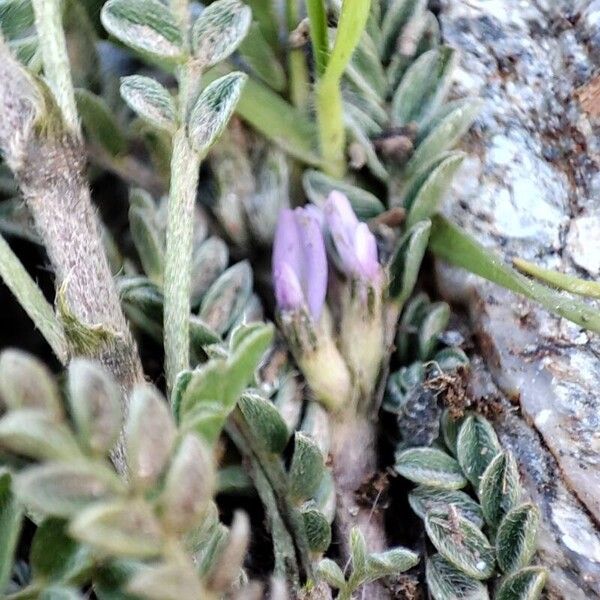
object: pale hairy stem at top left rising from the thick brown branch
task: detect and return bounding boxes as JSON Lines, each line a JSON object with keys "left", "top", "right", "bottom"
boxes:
{"left": 33, "top": 0, "right": 81, "bottom": 135}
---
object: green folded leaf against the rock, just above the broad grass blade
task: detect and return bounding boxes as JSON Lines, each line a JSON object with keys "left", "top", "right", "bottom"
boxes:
{"left": 406, "top": 152, "right": 466, "bottom": 227}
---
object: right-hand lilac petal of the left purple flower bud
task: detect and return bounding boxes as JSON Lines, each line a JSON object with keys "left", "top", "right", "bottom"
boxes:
{"left": 295, "top": 208, "right": 327, "bottom": 321}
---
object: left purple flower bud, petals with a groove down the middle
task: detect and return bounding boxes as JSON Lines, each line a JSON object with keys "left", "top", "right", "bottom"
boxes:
{"left": 273, "top": 207, "right": 327, "bottom": 322}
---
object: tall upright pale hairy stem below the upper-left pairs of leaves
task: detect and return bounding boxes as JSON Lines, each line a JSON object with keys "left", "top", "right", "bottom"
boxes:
{"left": 164, "top": 127, "right": 200, "bottom": 389}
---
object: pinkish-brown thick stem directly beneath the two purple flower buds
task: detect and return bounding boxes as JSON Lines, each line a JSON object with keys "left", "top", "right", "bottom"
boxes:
{"left": 331, "top": 417, "right": 390, "bottom": 600}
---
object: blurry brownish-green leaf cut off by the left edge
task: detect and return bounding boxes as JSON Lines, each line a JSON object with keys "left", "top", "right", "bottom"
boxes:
{"left": 0, "top": 350, "right": 64, "bottom": 421}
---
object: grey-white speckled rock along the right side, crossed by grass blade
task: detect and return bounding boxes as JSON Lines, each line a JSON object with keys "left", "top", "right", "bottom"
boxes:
{"left": 437, "top": 0, "right": 600, "bottom": 599}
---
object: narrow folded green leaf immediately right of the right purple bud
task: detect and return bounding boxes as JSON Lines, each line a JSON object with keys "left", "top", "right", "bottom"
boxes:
{"left": 389, "top": 220, "right": 431, "bottom": 304}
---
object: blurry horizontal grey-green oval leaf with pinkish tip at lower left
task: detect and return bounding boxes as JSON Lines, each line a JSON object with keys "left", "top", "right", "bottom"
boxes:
{"left": 14, "top": 462, "right": 125, "bottom": 517}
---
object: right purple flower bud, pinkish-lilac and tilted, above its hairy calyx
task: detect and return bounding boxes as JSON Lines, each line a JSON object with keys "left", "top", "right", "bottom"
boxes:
{"left": 324, "top": 191, "right": 381, "bottom": 282}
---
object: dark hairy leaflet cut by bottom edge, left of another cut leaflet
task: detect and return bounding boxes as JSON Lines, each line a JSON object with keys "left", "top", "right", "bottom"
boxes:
{"left": 426, "top": 554, "right": 490, "bottom": 600}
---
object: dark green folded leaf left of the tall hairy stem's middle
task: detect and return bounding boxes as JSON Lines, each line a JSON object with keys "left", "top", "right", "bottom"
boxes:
{"left": 129, "top": 188, "right": 165, "bottom": 285}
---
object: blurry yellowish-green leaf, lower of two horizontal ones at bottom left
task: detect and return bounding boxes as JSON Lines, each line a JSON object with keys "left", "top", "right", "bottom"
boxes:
{"left": 69, "top": 500, "right": 163, "bottom": 558}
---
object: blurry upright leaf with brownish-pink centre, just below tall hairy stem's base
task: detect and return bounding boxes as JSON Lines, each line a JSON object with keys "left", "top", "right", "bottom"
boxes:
{"left": 125, "top": 385, "right": 176, "bottom": 488}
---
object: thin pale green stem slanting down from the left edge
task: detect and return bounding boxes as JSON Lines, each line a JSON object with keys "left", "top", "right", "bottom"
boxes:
{"left": 0, "top": 231, "right": 67, "bottom": 364}
